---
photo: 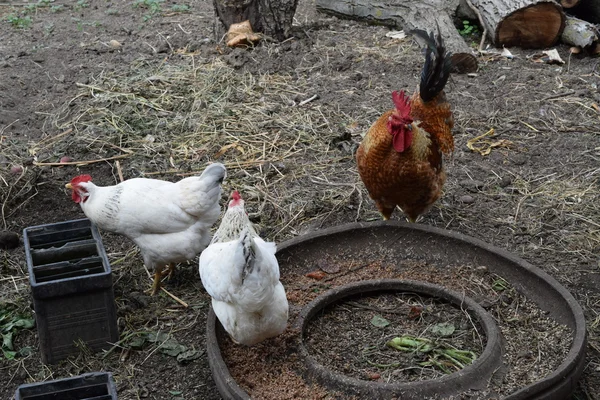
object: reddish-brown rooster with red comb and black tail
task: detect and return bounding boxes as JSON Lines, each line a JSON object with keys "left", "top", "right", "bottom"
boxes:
{"left": 356, "top": 30, "right": 454, "bottom": 222}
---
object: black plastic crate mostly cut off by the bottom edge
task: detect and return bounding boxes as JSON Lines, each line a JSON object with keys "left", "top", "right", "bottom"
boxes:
{"left": 15, "top": 372, "right": 117, "bottom": 400}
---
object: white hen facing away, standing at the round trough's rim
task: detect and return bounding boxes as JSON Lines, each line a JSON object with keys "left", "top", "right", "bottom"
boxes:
{"left": 199, "top": 191, "right": 288, "bottom": 346}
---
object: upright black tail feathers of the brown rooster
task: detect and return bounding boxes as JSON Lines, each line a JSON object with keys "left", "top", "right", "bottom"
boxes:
{"left": 411, "top": 27, "right": 452, "bottom": 102}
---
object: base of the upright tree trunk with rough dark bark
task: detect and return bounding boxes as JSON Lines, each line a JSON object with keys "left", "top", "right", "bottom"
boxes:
{"left": 213, "top": 0, "right": 298, "bottom": 41}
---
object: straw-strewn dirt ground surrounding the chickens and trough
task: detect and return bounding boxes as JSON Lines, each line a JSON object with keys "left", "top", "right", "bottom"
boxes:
{"left": 0, "top": 0, "right": 600, "bottom": 399}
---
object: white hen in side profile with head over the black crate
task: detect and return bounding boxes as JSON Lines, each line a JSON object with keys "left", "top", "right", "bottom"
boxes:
{"left": 66, "top": 163, "right": 227, "bottom": 295}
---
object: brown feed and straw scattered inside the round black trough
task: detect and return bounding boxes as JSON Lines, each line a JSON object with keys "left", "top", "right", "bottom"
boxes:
{"left": 221, "top": 260, "right": 572, "bottom": 400}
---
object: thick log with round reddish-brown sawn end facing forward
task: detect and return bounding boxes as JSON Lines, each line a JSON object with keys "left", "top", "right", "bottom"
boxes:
{"left": 470, "top": 0, "right": 568, "bottom": 48}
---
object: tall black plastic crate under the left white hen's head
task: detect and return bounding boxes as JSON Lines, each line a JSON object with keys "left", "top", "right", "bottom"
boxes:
{"left": 23, "top": 219, "right": 119, "bottom": 364}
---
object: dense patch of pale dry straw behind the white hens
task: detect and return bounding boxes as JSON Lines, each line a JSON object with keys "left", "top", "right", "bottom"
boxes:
{"left": 22, "top": 56, "right": 370, "bottom": 240}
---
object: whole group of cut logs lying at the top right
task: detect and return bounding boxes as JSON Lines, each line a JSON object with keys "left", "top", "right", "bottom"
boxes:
{"left": 316, "top": 0, "right": 600, "bottom": 72}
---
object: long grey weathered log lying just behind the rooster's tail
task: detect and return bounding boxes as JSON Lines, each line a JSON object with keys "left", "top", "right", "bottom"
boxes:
{"left": 316, "top": 0, "right": 477, "bottom": 73}
